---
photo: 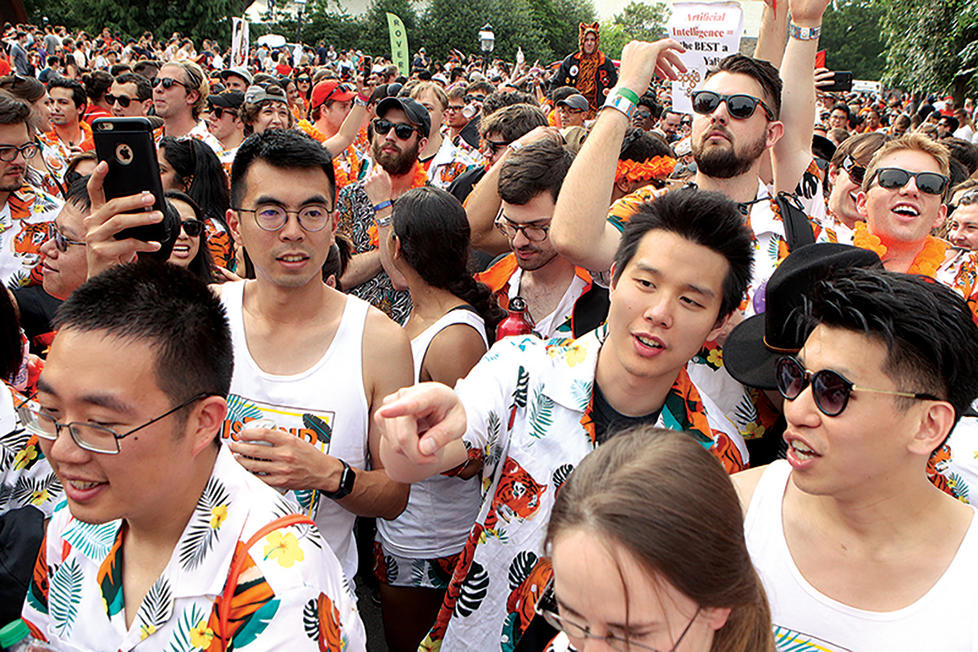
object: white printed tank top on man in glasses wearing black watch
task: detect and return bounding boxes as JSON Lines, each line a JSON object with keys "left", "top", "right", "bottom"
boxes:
{"left": 221, "top": 281, "right": 370, "bottom": 581}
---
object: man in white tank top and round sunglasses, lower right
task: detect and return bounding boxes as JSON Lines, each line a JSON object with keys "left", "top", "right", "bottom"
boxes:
{"left": 734, "top": 269, "right": 978, "bottom": 652}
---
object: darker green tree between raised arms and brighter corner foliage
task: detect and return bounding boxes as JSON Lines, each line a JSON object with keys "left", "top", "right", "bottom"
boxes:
{"left": 819, "top": 0, "right": 886, "bottom": 81}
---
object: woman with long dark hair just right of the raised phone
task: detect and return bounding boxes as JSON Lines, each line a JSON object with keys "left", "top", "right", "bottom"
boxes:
{"left": 159, "top": 138, "right": 235, "bottom": 271}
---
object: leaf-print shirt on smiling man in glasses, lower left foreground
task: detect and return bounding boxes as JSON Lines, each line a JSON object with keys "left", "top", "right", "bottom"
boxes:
{"left": 23, "top": 446, "right": 366, "bottom": 652}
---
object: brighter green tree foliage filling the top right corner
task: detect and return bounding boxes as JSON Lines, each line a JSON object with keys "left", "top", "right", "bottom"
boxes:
{"left": 878, "top": 0, "right": 978, "bottom": 104}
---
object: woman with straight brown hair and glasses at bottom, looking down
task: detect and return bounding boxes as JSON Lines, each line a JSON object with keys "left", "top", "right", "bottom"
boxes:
{"left": 537, "top": 426, "right": 774, "bottom": 652}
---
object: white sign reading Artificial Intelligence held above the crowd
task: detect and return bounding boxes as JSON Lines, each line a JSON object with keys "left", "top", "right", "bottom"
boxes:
{"left": 667, "top": 2, "right": 744, "bottom": 113}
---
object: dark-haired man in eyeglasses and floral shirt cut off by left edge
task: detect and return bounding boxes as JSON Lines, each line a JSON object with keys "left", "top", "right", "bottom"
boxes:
{"left": 0, "top": 95, "right": 61, "bottom": 287}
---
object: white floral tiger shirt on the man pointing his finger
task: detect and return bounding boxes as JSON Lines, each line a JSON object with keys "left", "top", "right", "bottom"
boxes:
{"left": 420, "top": 326, "right": 745, "bottom": 651}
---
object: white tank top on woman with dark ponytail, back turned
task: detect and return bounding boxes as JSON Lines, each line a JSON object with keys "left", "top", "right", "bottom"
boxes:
{"left": 377, "top": 308, "right": 489, "bottom": 559}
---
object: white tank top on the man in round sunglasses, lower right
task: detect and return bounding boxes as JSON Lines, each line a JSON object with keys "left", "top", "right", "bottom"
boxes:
{"left": 744, "top": 460, "right": 978, "bottom": 652}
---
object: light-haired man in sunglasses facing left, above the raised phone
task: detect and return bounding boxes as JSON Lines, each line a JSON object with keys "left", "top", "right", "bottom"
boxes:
{"left": 152, "top": 61, "right": 223, "bottom": 153}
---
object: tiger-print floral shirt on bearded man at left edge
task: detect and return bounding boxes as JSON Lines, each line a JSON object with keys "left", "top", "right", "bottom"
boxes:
{"left": 0, "top": 183, "right": 61, "bottom": 288}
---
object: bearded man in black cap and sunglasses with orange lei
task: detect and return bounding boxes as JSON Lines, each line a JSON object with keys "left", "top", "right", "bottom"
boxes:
{"left": 336, "top": 97, "right": 431, "bottom": 323}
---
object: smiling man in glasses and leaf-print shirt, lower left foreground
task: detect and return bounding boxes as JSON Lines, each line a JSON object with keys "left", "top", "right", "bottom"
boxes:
{"left": 18, "top": 262, "right": 365, "bottom": 650}
